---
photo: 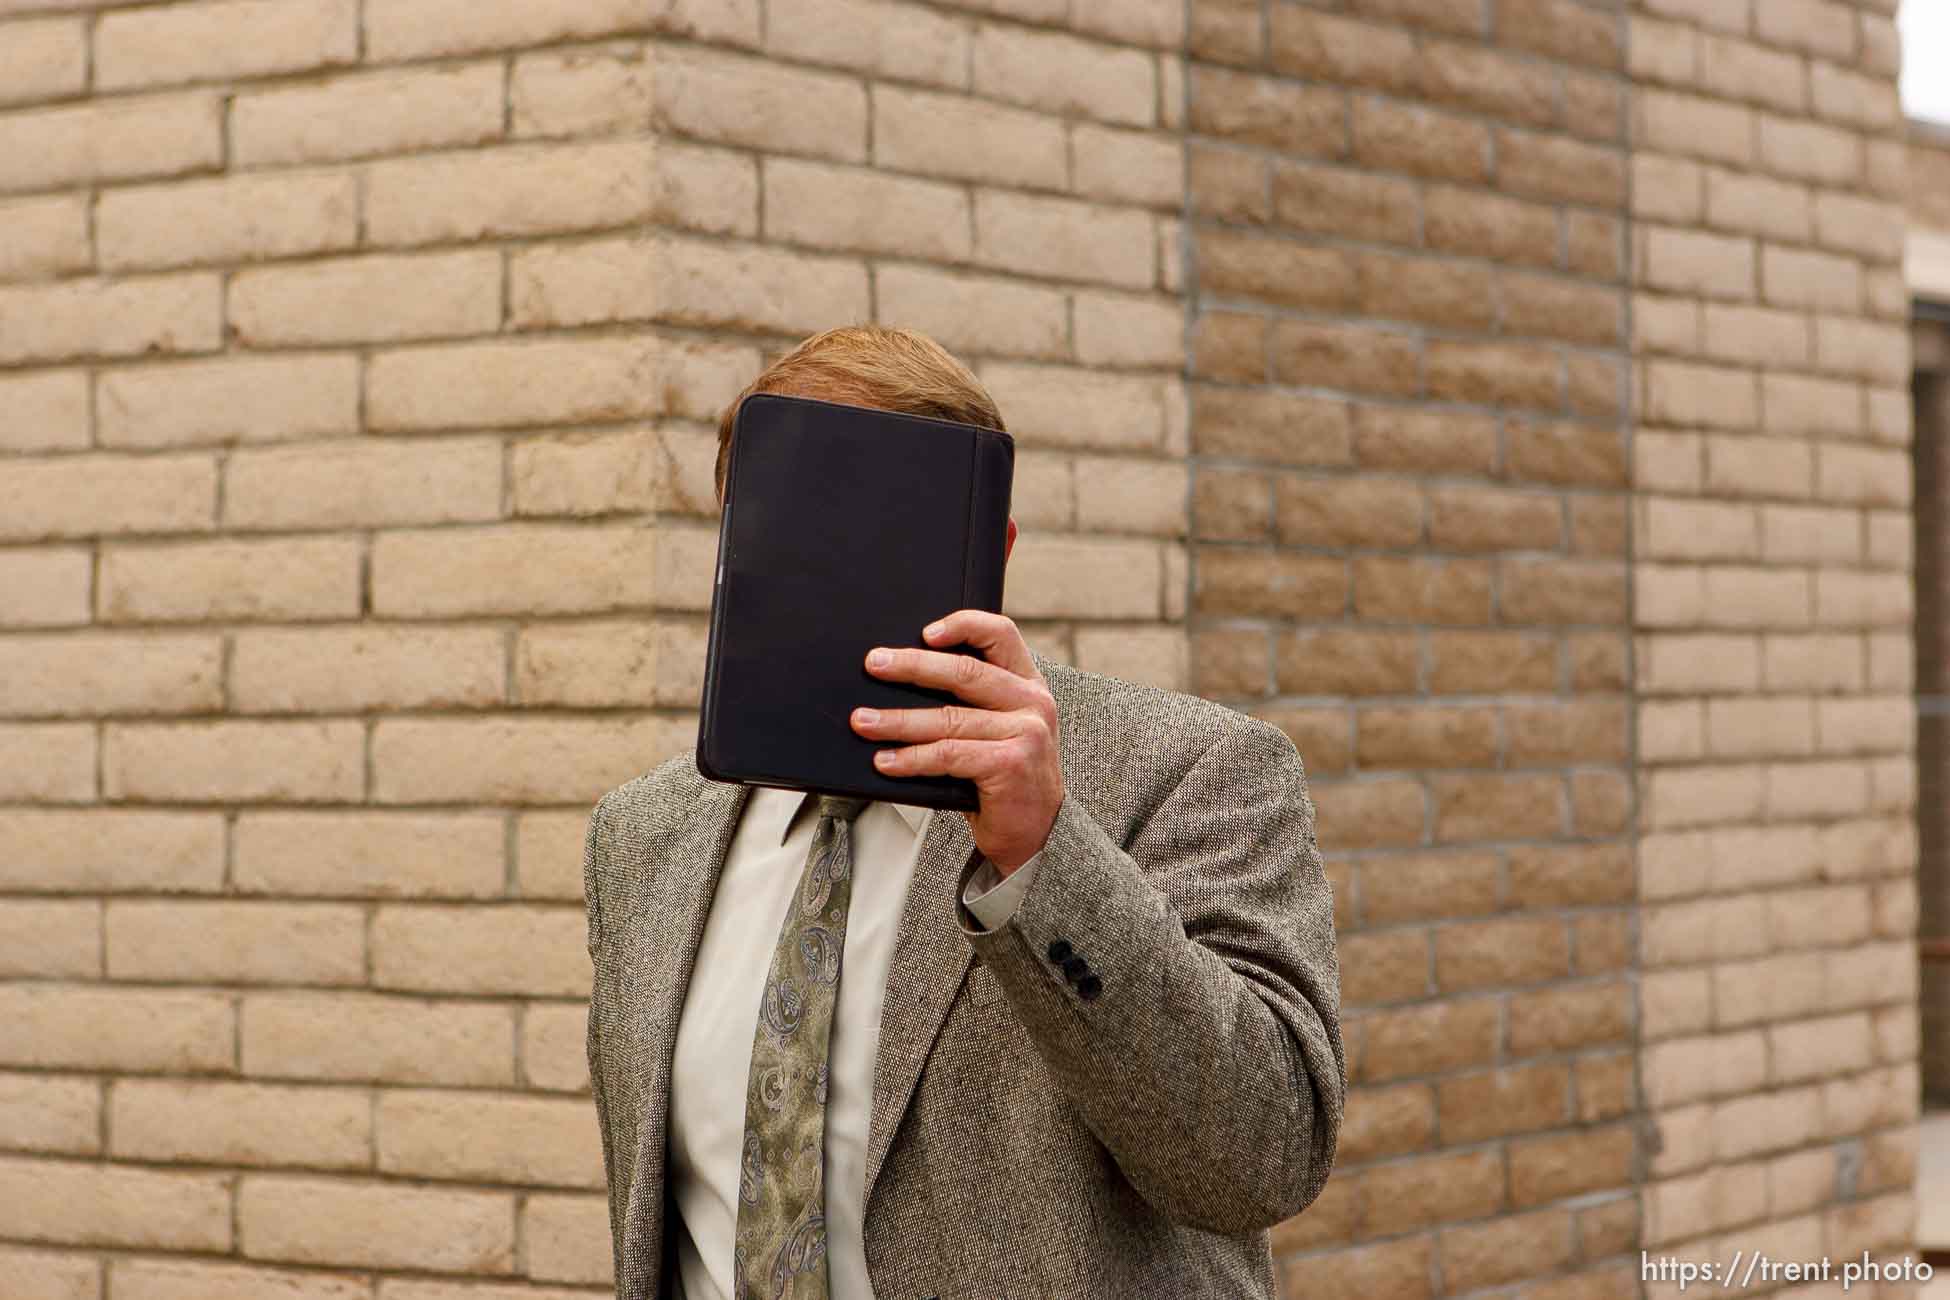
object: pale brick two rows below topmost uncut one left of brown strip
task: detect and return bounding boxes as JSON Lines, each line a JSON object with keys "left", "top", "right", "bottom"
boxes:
{"left": 973, "top": 189, "right": 1154, "bottom": 288}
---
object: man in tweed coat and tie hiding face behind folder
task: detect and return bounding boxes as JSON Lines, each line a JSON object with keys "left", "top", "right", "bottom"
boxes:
{"left": 583, "top": 327, "right": 1346, "bottom": 1300}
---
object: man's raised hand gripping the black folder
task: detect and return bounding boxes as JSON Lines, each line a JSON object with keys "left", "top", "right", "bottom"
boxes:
{"left": 852, "top": 610, "right": 1063, "bottom": 875}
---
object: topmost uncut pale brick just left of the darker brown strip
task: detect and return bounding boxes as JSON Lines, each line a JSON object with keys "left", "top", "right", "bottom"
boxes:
{"left": 971, "top": 25, "right": 1156, "bottom": 127}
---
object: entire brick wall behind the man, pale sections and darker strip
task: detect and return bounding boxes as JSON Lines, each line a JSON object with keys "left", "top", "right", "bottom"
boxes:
{"left": 0, "top": 0, "right": 1950, "bottom": 1300}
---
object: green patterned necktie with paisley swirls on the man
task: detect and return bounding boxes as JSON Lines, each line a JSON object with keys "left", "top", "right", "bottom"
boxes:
{"left": 731, "top": 795, "right": 868, "bottom": 1300}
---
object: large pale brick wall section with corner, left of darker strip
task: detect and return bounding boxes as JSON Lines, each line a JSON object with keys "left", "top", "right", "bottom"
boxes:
{"left": 0, "top": 0, "right": 1188, "bottom": 1300}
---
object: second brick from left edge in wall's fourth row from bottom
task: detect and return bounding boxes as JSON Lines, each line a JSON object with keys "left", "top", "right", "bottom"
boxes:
{"left": 240, "top": 992, "right": 515, "bottom": 1088}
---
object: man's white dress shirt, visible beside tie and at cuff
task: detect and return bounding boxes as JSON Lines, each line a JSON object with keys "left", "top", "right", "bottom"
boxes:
{"left": 669, "top": 785, "right": 1041, "bottom": 1300}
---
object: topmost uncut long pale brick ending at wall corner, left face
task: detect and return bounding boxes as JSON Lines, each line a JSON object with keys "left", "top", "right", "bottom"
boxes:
{"left": 367, "top": 140, "right": 657, "bottom": 246}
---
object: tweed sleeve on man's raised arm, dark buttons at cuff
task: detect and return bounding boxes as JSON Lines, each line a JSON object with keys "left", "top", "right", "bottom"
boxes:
{"left": 956, "top": 719, "right": 1347, "bottom": 1232}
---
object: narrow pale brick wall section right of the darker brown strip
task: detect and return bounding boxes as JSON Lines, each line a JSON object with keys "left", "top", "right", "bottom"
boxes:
{"left": 1630, "top": 0, "right": 1917, "bottom": 1294}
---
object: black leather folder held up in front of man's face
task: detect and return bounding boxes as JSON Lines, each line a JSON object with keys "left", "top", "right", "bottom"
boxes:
{"left": 698, "top": 394, "right": 1016, "bottom": 811}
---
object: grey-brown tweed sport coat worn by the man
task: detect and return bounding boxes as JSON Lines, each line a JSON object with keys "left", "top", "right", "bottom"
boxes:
{"left": 583, "top": 655, "right": 1347, "bottom": 1300}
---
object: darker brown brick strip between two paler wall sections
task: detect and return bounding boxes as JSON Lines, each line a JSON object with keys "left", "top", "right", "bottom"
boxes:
{"left": 1188, "top": 0, "right": 1640, "bottom": 1298}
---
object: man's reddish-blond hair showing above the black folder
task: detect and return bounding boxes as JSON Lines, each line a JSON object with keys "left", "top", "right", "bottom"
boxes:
{"left": 718, "top": 325, "right": 1006, "bottom": 505}
